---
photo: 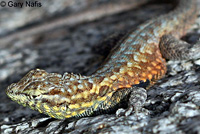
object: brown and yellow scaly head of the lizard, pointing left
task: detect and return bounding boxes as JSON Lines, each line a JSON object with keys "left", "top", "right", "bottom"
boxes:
{"left": 6, "top": 69, "right": 69, "bottom": 109}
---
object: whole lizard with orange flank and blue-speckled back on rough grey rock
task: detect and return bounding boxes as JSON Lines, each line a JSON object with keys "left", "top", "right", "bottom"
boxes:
{"left": 6, "top": 0, "right": 200, "bottom": 119}
